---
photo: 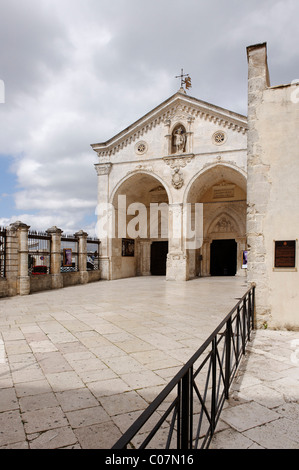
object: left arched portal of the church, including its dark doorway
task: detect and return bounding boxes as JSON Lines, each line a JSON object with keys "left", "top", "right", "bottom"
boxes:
{"left": 109, "top": 172, "right": 169, "bottom": 279}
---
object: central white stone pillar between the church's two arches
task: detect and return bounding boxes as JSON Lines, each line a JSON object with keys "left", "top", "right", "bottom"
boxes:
{"left": 166, "top": 203, "right": 189, "bottom": 281}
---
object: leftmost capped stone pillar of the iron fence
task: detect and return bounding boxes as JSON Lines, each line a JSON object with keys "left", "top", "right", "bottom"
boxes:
{"left": 11, "top": 221, "right": 30, "bottom": 295}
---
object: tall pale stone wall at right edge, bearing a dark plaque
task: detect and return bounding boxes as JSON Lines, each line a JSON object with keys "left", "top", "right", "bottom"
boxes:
{"left": 247, "top": 44, "right": 299, "bottom": 329}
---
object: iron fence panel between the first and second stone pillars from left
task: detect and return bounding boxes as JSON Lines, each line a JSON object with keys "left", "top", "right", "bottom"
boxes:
{"left": 28, "top": 231, "right": 51, "bottom": 276}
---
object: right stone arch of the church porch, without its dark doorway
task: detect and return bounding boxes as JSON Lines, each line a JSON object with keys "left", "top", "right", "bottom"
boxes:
{"left": 184, "top": 161, "right": 247, "bottom": 277}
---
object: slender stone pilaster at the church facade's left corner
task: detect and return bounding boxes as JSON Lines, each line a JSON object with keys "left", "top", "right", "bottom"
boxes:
{"left": 95, "top": 163, "right": 112, "bottom": 279}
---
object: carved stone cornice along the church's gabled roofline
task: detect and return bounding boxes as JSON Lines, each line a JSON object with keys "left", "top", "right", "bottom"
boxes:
{"left": 91, "top": 92, "right": 247, "bottom": 158}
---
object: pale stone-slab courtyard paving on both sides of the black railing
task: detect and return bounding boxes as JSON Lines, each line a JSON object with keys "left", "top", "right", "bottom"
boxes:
{"left": 0, "top": 277, "right": 299, "bottom": 449}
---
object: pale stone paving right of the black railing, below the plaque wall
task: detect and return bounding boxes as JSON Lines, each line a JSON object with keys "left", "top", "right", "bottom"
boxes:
{"left": 210, "top": 330, "right": 299, "bottom": 449}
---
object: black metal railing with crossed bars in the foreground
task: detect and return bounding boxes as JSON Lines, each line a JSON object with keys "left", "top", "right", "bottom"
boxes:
{"left": 112, "top": 285, "right": 255, "bottom": 449}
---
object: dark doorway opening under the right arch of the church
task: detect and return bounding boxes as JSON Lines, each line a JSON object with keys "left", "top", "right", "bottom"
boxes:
{"left": 211, "top": 240, "right": 237, "bottom": 276}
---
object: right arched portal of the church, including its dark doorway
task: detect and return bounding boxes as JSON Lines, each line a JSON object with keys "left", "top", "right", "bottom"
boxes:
{"left": 186, "top": 164, "right": 246, "bottom": 278}
